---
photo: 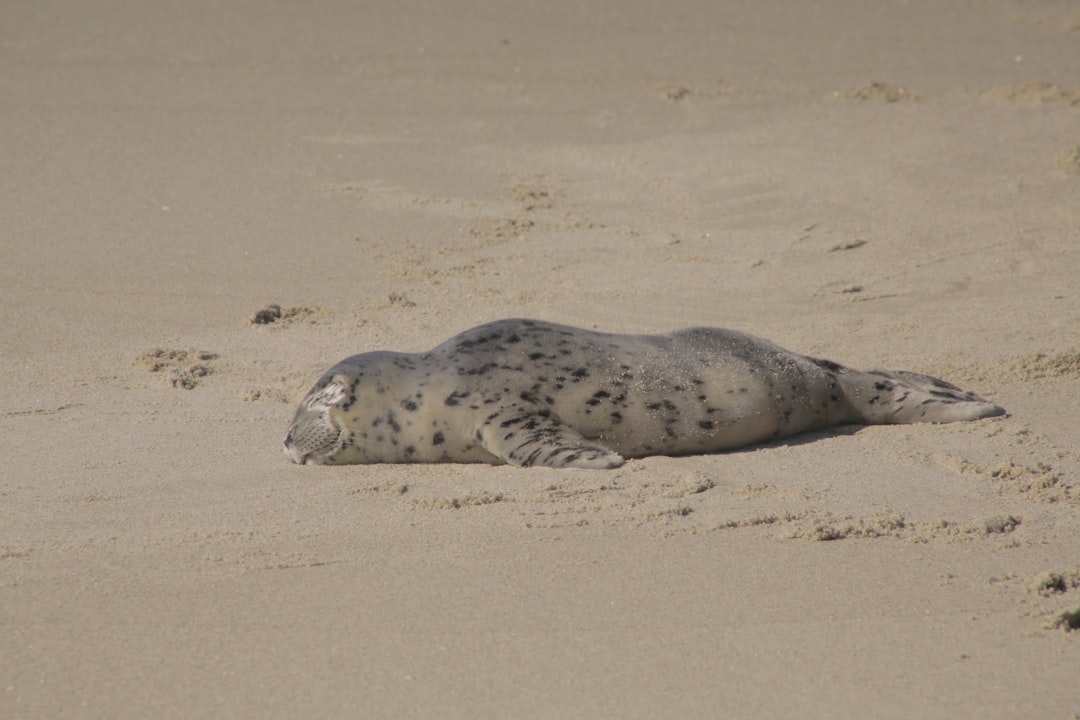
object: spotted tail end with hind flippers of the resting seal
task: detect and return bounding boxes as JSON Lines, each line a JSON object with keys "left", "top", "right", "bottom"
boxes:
{"left": 837, "top": 370, "right": 1005, "bottom": 425}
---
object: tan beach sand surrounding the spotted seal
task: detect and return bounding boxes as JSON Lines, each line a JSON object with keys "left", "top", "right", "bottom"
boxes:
{"left": 0, "top": 0, "right": 1080, "bottom": 719}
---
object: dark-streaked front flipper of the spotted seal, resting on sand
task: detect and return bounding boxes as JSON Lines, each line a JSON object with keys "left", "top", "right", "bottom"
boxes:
{"left": 477, "top": 405, "right": 625, "bottom": 470}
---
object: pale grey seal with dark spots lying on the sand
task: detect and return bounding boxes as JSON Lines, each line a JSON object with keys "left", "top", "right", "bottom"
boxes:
{"left": 285, "top": 320, "right": 1004, "bottom": 468}
